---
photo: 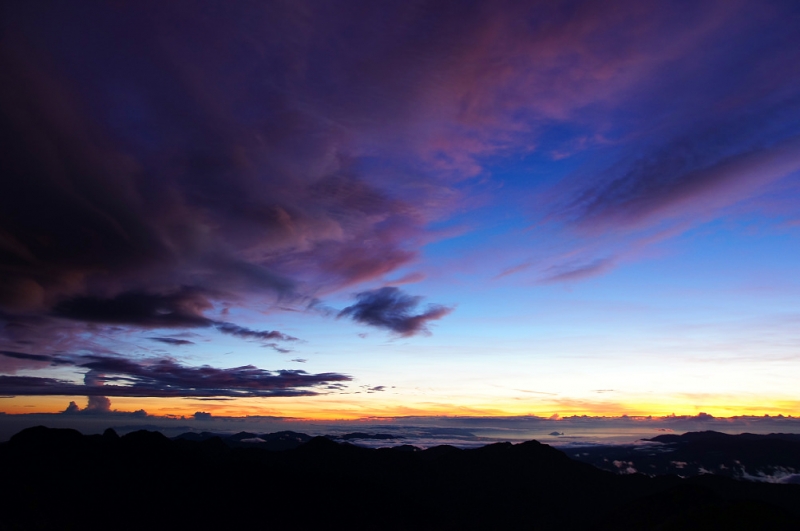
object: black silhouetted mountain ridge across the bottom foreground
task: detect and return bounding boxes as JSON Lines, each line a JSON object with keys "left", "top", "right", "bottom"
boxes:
{"left": 0, "top": 427, "right": 800, "bottom": 531}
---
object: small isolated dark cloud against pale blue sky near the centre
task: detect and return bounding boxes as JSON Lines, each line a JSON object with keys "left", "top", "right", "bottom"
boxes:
{"left": 338, "top": 287, "right": 453, "bottom": 337}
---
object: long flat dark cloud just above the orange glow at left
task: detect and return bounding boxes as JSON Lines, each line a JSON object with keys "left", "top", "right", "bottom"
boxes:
{"left": 0, "top": 355, "right": 351, "bottom": 396}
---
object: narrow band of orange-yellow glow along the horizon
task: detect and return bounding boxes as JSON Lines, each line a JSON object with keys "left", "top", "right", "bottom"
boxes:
{"left": 0, "top": 395, "right": 800, "bottom": 421}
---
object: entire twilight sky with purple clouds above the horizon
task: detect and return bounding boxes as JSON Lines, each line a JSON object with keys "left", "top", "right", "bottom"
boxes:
{"left": 0, "top": 0, "right": 800, "bottom": 436}
